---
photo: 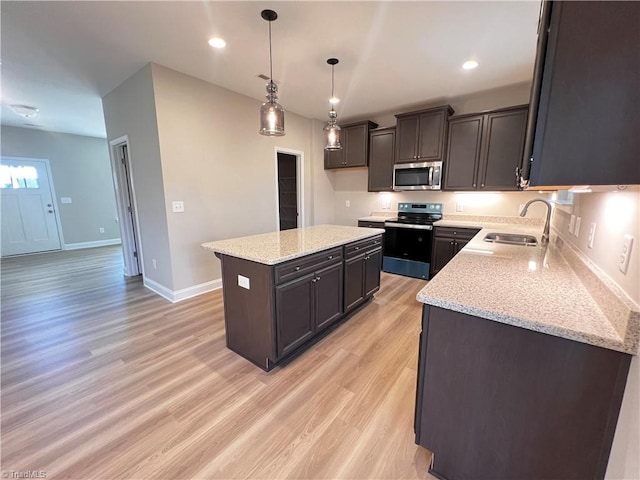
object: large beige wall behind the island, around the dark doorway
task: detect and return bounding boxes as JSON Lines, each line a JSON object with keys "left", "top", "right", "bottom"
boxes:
{"left": 151, "top": 64, "right": 330, "bottom": 290}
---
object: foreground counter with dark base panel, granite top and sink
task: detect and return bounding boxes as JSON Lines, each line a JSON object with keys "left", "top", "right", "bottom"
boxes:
{"left": 415, "top": 222, "right": 640, "bottom": 480}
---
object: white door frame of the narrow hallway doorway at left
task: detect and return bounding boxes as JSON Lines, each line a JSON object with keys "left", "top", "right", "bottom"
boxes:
{"left": 109, "top": 135, "right": 144, "bottom": 277}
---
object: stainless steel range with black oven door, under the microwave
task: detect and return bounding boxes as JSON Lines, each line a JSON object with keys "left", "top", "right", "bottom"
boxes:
{"left": 382, "top": 203, "right": 442, "bottom": 280}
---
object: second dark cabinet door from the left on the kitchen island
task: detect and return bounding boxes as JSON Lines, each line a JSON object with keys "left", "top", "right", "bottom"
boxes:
{"left": 313, "top": 263, "right": 343, "bottom": 330}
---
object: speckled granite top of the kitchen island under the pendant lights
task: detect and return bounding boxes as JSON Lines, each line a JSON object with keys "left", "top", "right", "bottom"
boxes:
{"left": 202, "top": 225, "right": 384, "bottom": 265}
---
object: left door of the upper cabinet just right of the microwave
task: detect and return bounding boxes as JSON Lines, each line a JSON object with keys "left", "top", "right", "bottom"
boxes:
{"left": 444, "top": 115, "right": 482, "bottom": 190}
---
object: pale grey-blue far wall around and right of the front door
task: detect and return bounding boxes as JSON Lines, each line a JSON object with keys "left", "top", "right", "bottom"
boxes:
{"left": 1, "top": 125, "right": 120, "bottom": 246}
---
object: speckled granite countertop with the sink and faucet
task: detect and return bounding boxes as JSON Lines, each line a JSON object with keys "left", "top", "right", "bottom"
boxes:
{"left": 417, "top": 219, "right": 640, "bottom": 355}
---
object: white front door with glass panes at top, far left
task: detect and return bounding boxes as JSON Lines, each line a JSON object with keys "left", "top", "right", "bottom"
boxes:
{"left": 0, "top": 158, "right": 60, "bottom": 257}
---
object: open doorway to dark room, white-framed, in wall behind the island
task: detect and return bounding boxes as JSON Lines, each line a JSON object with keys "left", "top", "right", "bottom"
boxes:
{"left": 276, "top": 148, "right": 304, "bottom": 230}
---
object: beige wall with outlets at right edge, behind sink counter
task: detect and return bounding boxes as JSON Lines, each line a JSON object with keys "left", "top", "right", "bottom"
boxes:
{"left": 553, "top": 191, "right": 640, "bottom": 480}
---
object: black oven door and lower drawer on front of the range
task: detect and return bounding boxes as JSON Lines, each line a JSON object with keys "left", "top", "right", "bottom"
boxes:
{"left": 382, "top": 222, "right": 433, "bottom": 280}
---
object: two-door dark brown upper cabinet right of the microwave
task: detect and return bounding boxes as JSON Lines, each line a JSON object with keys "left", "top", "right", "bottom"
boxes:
{"left": 444, "top": 105, "right": 528, "bottom": 191}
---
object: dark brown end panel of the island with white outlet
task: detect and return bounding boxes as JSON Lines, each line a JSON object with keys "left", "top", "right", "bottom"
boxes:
{"left": 221, "top": 255, "right": 277, "bottom": 370}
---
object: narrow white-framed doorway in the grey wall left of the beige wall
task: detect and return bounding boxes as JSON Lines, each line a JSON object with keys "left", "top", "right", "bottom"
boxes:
{"left": 109, "top": 136, "right": 143, "bottom": 276}
